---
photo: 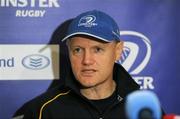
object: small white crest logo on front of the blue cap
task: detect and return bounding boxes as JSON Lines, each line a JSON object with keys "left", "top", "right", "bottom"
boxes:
{"left": 78, "top": 15, "right": 97, "bottom": 27}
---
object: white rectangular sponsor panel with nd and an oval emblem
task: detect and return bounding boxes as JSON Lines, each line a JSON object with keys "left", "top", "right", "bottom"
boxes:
{"left": 0, "top": 44, "right": 59, "bottom": 80}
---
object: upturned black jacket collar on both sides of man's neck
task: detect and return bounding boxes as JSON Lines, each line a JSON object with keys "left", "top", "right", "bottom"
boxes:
{"left": 65, "top": 63, "right": 140, "bottom": 98}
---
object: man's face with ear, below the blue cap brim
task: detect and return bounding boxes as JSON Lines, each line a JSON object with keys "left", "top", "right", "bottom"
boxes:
{"left": 68, "top": 36, "right": 123, "bottom": 88}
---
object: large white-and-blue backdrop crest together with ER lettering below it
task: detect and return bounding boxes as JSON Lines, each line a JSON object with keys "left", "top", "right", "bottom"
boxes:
{"left": 119, "top": 31, "right": 154, "bottom": 89}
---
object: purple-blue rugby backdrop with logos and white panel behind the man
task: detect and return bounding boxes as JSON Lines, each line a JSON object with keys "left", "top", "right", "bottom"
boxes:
{"left": 0, "top": 0, "right": 180, "bottom": 119}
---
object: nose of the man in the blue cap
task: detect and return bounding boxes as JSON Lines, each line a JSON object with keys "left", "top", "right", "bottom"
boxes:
{"left": 82, "top": 51, "right": 94, "bottom": 65}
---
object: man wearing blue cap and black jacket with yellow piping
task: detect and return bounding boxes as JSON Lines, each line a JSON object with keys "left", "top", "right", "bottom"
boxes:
{"left": 13, "top": 10, "right": 139, "bottom": 119}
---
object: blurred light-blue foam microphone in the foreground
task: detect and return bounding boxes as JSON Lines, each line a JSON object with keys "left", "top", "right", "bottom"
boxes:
{"left": 125, "top": 90, "right": 161, "bottom": 119}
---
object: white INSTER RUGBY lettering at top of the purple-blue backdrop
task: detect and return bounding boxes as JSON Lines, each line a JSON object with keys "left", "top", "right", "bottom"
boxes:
{"left": 0, "top": 0, "right": 60, "bottom": 17}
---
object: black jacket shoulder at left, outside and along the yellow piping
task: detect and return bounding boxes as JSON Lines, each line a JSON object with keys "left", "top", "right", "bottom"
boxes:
{"left": 13, "top": 86, "right": 69, "bottom": 119}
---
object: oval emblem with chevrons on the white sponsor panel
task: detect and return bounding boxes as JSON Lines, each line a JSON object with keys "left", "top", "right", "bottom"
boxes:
{"left": 22, "top": 54, "right": 50, "bottom": 70}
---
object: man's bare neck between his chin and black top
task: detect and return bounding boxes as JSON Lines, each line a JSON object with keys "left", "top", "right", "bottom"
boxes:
{"left": 80, "top": 80, "right": 116, "bottom": 100}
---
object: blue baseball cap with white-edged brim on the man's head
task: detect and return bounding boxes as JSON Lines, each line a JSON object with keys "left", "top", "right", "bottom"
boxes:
{"left": 62, "top": 10, "right": 120, "bottom": 42}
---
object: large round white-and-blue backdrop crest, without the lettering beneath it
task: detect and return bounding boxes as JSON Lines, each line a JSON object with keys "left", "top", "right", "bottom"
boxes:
{"left": 119, "top": 31, "right": 151, "bottom": 75}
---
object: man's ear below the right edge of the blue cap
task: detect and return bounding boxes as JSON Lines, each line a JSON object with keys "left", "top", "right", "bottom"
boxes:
{"left": 116, "top": 41, "right": 124, "bottom": 61}
